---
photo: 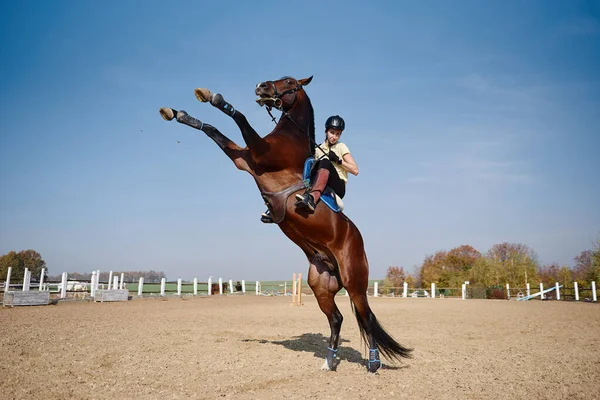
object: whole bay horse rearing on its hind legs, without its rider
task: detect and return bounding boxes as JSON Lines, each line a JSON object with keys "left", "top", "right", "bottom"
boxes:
{"left": 160, "top": 76, "right": 412, "bottom": 373}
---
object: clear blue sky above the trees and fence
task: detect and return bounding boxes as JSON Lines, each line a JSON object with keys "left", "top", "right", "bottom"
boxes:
{"left": 0, "top": 0, "right": 600, "bottom": 280}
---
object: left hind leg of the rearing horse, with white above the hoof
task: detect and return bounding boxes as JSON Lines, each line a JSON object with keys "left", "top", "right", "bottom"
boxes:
{"left": 308, "top": 261, "right": 344, "bottom": 371}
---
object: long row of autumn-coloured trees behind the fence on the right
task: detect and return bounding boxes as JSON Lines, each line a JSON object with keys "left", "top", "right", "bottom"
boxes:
{"left": 383, "top": 239, "right": 600, "bottom": 288}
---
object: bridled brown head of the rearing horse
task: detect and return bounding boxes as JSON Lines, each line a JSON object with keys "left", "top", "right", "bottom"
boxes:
{"left": 255, "top": 76, "right": 312, "bottom": 111}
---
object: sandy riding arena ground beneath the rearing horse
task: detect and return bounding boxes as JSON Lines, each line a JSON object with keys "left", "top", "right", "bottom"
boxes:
{"left": 0, "top": 295, "right": 600, "bottom": 400}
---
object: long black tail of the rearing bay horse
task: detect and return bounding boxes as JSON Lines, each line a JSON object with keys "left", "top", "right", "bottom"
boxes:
{"left": 350, "top": 296, "right": 413, "bottom": 361}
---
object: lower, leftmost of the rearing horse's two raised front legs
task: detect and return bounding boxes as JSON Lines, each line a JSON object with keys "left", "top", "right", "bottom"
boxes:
{"left": 160, "top": 107, "right": 250, "bottom": 172}
